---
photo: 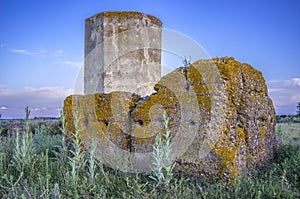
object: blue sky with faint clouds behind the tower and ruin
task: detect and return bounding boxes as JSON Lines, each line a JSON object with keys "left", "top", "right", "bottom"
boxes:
{"left": 0, "top": 0, "right": 300, "bottom": 118}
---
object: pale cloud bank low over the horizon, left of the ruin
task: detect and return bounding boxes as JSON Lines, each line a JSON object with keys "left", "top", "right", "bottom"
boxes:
{"left": 0, "top": 86, "right": 73, "bottom": 118}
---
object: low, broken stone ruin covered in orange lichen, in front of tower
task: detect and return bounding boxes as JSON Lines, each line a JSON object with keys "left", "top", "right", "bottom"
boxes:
{"left": 64, "top": 57, "right": 278, "bottom": 179}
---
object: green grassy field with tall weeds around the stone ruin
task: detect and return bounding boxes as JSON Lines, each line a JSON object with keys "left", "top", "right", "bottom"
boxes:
{"left": 0, "top": 110, "right": 300, "bottom": 199}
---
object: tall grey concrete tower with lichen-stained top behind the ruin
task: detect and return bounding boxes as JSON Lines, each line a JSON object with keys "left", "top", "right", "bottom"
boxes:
{"left": 84, "top": 12, "right": 162, "bottom": 96}
